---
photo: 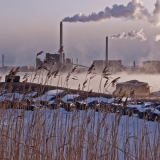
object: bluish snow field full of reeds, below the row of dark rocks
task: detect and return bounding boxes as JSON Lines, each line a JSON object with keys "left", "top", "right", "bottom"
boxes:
{"left": 0, "top": 107, "right": 160, "bottom": 160}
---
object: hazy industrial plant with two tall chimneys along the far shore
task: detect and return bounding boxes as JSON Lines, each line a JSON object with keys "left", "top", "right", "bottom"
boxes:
{"left": 0, "top": 22, "right": 160, "bottom": 74}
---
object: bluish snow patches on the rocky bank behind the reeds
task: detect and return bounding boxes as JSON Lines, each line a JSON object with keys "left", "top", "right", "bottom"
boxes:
{"left": 0, "top": 89, "right": 160, "bottom": 119}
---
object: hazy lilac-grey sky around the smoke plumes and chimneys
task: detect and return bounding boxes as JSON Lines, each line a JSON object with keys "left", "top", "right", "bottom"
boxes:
{"left": 0, "top": 0, "right": 160, "bottom": 65}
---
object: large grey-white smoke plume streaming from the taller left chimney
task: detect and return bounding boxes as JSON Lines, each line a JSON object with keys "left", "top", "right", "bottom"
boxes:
{"left": 62, "top": 0, "right": 160, "bottom": 26}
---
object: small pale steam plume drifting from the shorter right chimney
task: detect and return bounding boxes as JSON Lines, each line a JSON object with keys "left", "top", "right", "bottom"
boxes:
{"left": 110, "top": 29, "right": 147, "bottom": 41}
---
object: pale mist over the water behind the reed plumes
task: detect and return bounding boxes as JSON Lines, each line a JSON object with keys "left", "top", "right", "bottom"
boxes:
{"left": 2, "top": 73, "right": 160, "bottom": 93}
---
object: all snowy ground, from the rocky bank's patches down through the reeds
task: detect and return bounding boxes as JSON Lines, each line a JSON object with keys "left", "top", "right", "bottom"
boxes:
{"left": 0, "top": 90, "right": 160, "bottom": 160}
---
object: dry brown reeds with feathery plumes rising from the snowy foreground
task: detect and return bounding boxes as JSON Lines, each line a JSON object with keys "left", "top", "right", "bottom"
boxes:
{"left": 0, "top": 51, "right": 160, "bottom": 160}
